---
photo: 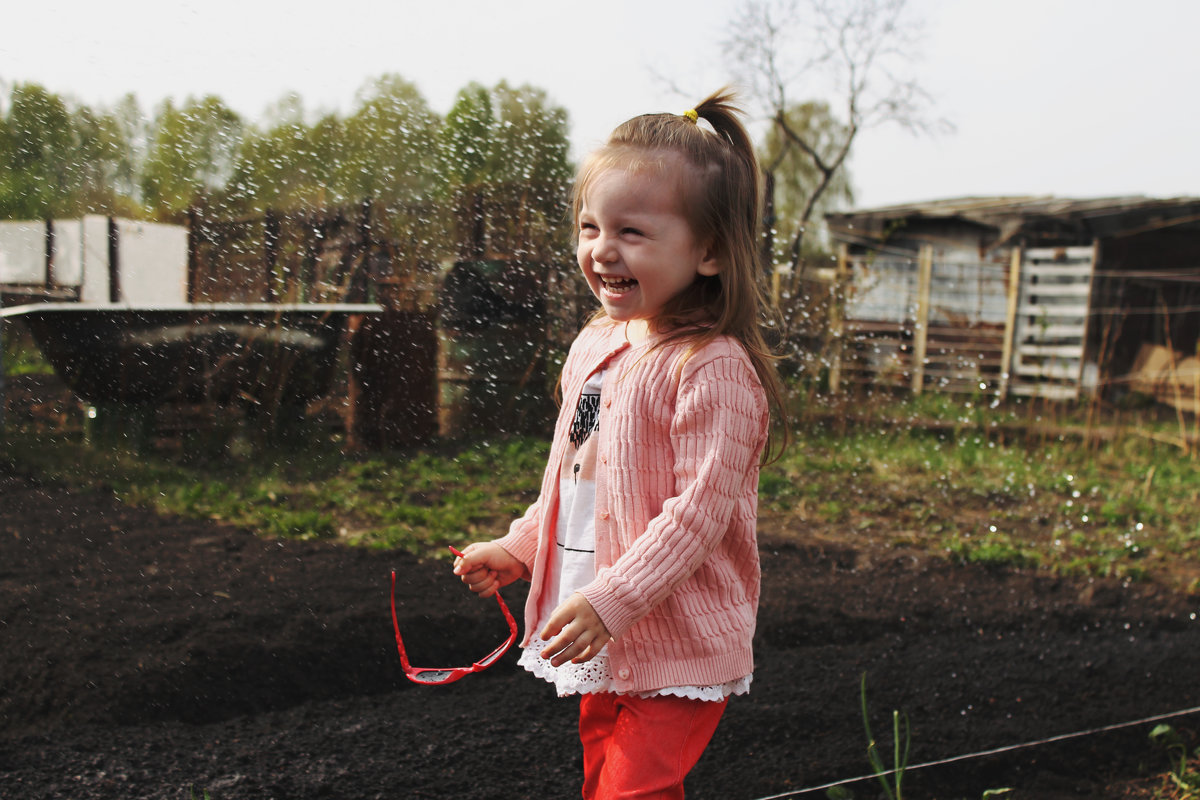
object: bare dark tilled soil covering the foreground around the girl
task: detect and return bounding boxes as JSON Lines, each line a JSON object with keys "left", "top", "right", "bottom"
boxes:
{"left": 0, "top": 468, "right": 1200, "bottom": 800}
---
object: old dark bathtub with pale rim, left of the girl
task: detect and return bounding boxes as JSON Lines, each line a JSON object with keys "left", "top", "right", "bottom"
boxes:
{"left": 0, "top": 302, "right": 380, "bottom": 405}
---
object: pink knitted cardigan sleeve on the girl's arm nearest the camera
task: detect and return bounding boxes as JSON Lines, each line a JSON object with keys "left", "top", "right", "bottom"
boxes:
{"left": 582, "top": 353, "right": 767, "bottom": 638}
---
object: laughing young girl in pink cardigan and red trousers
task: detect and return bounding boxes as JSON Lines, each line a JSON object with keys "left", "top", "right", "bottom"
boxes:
{"left": 454, "top": 92, "right": 780, "bottom": 799}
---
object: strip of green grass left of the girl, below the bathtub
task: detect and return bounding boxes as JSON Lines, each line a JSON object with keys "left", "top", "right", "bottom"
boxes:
{"left": 4, "top": 433, "right": 548, "bottom": 553}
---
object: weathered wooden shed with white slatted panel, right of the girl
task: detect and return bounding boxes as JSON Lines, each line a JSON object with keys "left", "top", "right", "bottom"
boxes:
{"left": 822, "top": 197, "right": 1200, "bottom": 407}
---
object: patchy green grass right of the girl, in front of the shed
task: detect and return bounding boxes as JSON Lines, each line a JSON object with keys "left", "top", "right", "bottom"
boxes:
{"left": 760, "top": 396, "right": 1200, "bottom": 591}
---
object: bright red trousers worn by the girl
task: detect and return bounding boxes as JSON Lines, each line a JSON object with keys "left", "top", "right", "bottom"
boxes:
{"left": 580, "top": 692, "right": 727, "bottom": 800}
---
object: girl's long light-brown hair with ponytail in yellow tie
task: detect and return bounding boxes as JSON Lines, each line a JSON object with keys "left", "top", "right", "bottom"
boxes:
{"left": 571, "top": 89, "right": 787, "bottom": 459}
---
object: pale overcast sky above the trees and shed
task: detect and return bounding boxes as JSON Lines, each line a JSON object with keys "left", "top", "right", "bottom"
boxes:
{"left": 0, "top": 0, "right": 1200, "bottom": 207}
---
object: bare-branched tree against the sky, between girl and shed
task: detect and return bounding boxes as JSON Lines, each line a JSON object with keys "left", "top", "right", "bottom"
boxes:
{"left": 724, "top": 0, "right": 944, "bottom": 299}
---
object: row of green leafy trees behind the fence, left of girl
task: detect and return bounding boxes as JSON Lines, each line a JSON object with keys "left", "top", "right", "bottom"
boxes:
{"left": 0, "top": 74, "right": 572, "bottom": 268}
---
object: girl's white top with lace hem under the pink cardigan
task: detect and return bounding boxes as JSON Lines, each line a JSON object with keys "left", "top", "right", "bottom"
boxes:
{"left": 517, "top": 369, "right": 752, "bottom": 700}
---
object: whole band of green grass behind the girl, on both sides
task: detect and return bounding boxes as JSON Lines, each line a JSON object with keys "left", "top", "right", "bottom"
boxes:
{"left": 0, "top": 396, "right": 1200, "bottom": 591}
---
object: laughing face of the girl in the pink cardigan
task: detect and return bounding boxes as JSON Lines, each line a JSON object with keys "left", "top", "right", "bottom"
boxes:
{"left": 576, "top": 163, "right": 720, "bottom": 329}
